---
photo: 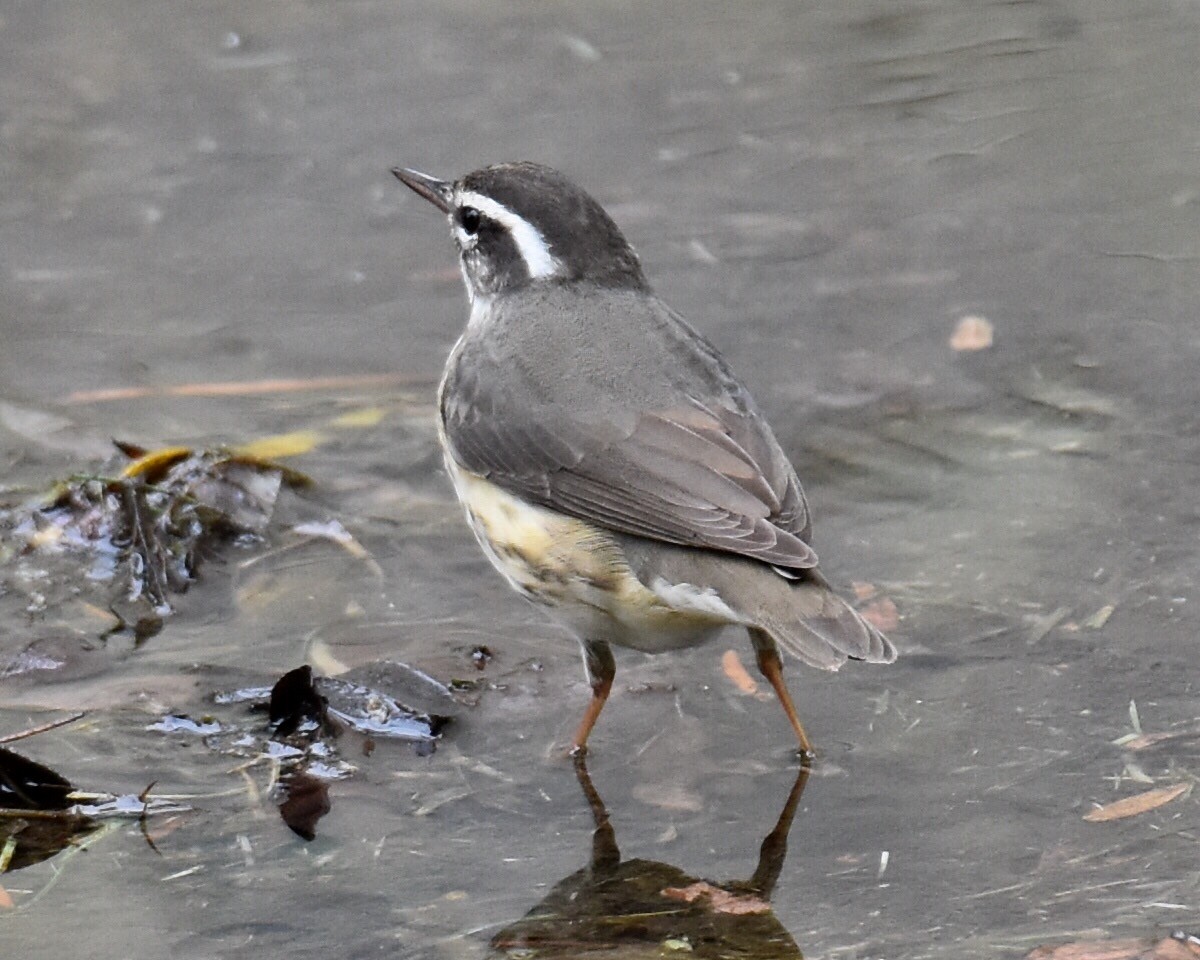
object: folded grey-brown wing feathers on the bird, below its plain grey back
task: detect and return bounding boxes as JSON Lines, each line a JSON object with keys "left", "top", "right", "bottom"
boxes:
{"left": 443, "top": 371, "right": 817, "bottom": 570}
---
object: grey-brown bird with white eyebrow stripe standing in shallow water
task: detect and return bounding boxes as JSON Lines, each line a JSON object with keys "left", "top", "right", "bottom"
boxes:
{"left": 392, "top": 162, "right": 896, "bottom": 758}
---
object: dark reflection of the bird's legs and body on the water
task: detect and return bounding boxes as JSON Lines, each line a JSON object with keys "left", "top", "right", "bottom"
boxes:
{"left": 492, "top": 757, "right": 809, "bottom": 960}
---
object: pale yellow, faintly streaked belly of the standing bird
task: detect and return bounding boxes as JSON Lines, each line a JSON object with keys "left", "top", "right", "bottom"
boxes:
{"left": 446, "top": 456, "right": 740, "bottom": 653}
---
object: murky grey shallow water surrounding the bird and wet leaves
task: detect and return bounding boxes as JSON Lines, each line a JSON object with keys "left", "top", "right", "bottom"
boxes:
{"left": 0, "top": 0, "right": 1200, "bottom": 960}
